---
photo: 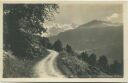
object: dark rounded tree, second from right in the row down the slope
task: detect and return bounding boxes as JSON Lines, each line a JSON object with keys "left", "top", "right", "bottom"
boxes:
{"left": 98, "top": 55, "right": 109, "bottom": 73}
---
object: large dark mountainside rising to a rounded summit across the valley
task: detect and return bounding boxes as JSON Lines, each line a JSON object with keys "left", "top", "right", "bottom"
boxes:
{"left": 49, "top": 20, "right": 123, "bottom": 63}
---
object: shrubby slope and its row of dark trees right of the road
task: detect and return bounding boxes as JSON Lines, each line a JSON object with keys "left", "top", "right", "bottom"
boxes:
{"left": 57, "top": 48, "right": 123, "bottom": 77}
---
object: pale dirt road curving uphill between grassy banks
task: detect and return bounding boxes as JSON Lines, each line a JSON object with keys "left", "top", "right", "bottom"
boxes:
{"left": 34, "top": 50, "right": 65, "bottom": 78}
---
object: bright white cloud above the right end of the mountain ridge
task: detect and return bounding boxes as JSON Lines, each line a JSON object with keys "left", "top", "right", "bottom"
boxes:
{"left": 104, "top": 13, "right": 122, "bottom": 23}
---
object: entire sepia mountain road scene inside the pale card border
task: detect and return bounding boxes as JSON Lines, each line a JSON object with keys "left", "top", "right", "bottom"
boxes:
{"left": 3, "top": 3, "right": 124, "bottom": 78}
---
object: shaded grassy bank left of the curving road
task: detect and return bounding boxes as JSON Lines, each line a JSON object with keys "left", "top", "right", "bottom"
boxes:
{"left": 3, "top": 51, "right": 48, "bottom": 78}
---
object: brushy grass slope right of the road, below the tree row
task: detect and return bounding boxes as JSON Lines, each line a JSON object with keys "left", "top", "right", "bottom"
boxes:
{"left": 57, "top": 52, "right": 111, "bottom": 78}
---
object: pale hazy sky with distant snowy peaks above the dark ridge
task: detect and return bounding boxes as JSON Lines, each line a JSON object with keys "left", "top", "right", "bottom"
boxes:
{"left": 45, "top": 3, "right": 123, "bottom": 36}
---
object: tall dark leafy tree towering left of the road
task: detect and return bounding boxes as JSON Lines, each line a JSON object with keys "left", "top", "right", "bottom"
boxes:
{"left": 3, "top": 4, "right": 58, "bottom": 56}
